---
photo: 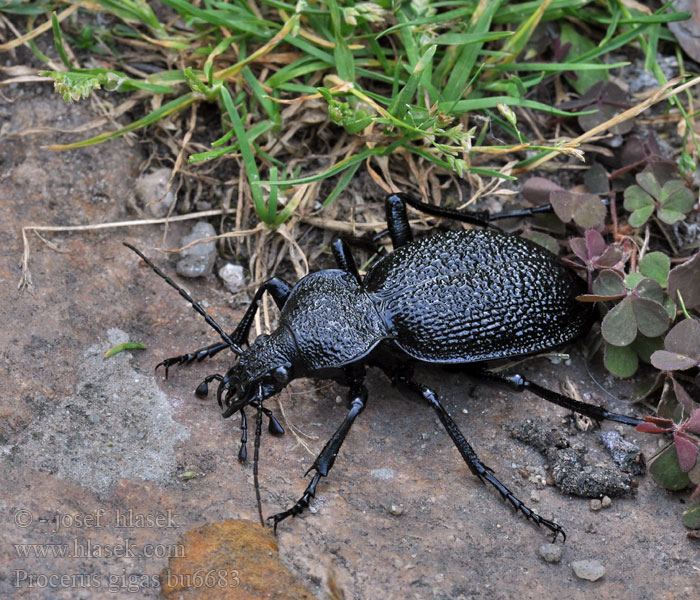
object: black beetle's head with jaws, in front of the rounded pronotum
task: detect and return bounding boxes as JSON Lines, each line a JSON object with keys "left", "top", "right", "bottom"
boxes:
{"left": 217, "top": 326, "right": 299, "bottom": 417}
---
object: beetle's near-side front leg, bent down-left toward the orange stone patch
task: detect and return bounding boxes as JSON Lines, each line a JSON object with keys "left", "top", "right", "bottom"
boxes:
{"left": 267, "top": 379, "right": 367, "bottom": 531}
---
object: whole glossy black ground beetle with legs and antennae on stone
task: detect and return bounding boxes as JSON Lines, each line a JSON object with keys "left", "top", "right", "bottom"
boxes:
{"left": 127, "top": 194, "right": 641, "bottom": 539}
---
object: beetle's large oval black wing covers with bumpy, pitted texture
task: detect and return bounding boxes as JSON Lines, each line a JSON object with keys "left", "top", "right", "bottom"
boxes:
{"left": 365, "top": 230, "right": 591, "bottom": 363}
